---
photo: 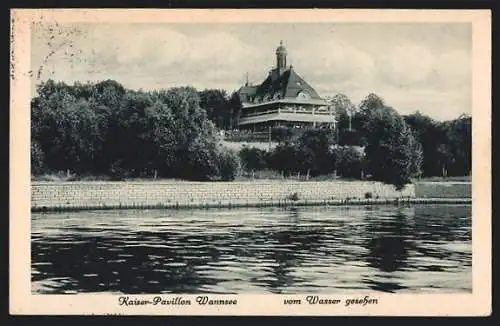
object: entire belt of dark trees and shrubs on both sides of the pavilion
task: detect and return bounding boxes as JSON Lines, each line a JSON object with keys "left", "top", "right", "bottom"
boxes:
{"left": 31, "top": 80, "right": 471, "bottom": 188}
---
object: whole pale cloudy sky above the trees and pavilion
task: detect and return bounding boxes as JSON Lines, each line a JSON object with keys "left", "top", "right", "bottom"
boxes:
{"left": 31, "top": 23, "right": 472, "bottom": 120}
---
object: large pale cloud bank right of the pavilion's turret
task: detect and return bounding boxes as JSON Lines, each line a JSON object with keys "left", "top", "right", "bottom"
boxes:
{"left": 294, "top": 39, "right": 472, "bottom": 120}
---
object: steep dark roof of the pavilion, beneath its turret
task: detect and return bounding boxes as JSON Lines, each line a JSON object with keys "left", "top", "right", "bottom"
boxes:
{"left": 238, "top": 68, "right": 323, "bottom": 102}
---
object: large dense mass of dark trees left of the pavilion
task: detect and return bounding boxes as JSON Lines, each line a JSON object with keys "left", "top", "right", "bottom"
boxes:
{"left": 31, "top": 80, "right": 238, "bottom": 180}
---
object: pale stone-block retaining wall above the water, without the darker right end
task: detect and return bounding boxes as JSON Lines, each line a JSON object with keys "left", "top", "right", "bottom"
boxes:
{"left": 31, "top": 181, "right": 415, "bottom": 209}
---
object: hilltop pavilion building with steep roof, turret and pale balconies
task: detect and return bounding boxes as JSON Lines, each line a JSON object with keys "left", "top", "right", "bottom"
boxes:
{"left": 238, "top": 42, "right": 335, "bottom": 131}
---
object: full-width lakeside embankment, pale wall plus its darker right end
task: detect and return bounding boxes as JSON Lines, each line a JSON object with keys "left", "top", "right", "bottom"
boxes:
{"left": 31, "top": 181, "right": 470, "bottom": 211}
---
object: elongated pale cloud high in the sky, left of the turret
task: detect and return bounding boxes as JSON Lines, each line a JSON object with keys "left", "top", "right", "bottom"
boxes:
{"left": 84, "top": 26, "right": 266, "bottom": 79}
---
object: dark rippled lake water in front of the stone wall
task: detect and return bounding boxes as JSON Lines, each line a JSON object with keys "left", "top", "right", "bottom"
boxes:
{"left": 31, "top": 205, "right": 472, "bottom": 294}
